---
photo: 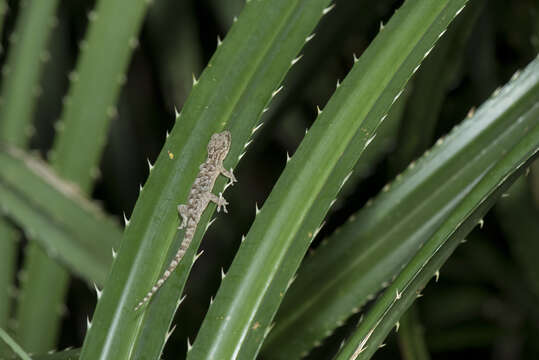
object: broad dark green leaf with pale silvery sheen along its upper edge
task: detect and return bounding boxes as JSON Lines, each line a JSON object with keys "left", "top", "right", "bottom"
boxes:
{"left": 263, "top": 54, "right": 538, "bottom": 358}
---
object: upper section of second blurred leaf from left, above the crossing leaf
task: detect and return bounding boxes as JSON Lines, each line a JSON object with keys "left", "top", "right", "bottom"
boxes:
{"left": 49, "top": 0, "right": 149, "bottom": 191}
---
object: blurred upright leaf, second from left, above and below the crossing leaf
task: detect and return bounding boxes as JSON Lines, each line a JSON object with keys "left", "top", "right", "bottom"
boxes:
{"left": 14, "top": 0, "right": 153, "bottom": 352}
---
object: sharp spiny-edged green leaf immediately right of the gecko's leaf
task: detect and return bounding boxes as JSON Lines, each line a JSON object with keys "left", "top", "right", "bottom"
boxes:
{"left": 193, "top": 0, "right": 465, "bottom": 359}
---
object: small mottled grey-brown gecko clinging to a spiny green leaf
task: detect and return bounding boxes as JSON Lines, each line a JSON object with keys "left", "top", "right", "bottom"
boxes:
{"left": 135, "top": 130, "right": 237, "bottom": 311}
